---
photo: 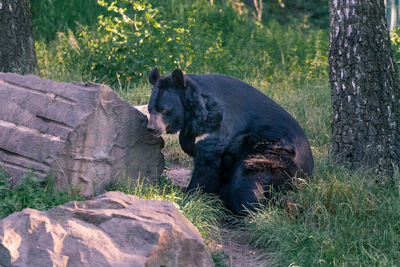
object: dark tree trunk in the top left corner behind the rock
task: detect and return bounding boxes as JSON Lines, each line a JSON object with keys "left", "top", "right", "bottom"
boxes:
{"left": 0, "top": 0, "right": 38, "bottom": 74}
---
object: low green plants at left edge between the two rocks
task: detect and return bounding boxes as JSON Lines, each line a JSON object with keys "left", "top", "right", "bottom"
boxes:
{"left": 0, "top": 167, "right": 83, "bottom": 219}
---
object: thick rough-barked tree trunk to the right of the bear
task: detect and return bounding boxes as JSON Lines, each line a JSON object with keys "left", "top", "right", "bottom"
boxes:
{"left": 329, "top": 0, "right": 400, "bottom": 178}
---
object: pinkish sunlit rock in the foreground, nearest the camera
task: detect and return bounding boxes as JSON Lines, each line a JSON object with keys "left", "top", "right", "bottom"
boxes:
{"left": 0, "top": 192, "right": 213, "bottom": 267}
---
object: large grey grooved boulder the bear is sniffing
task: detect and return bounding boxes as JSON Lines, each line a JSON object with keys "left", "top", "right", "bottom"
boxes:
{"left": 0, "top": 73, "right": 163, "bottom": 196}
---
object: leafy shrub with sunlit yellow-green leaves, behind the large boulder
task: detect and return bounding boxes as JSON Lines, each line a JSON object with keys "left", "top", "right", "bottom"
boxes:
{"left": 79, "top": 0, "right": 165, "bottom": 83}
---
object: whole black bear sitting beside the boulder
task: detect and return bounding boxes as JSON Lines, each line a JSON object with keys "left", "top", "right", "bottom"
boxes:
{"left": 147, "top": 67, "right": 314, "bottom": 214}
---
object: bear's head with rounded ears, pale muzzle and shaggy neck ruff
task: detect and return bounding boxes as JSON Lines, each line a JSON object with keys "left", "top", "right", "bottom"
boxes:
{"left": 147, "top": 67, "right": 222, "bottom": 136}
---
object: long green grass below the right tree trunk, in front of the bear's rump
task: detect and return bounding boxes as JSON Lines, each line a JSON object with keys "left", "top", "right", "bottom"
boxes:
{"left": 247, "top": 158, "right": 400, "bottom": 266}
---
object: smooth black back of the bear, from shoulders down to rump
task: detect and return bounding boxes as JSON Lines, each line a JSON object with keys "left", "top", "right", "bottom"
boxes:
{"left": 187, "top": 74, "right": 313, "bottom": 173}
